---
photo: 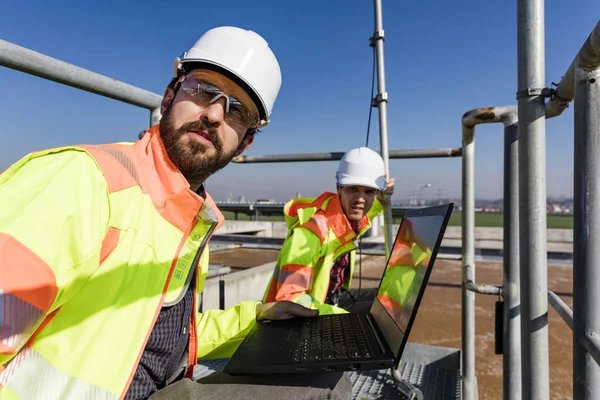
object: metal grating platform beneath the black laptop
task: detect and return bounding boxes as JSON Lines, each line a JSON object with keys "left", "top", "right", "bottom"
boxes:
{"left": 193, "top": 344, "right": 461, "bottom": 400}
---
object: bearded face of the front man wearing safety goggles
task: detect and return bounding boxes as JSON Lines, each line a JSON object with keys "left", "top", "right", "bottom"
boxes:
{"left": 159, "top": 69, "right": 258, "bottom": 189}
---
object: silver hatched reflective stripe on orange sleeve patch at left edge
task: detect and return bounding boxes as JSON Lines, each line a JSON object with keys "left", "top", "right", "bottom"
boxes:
{"left": 0, "top": 290, "right": 44, "bottom": 350}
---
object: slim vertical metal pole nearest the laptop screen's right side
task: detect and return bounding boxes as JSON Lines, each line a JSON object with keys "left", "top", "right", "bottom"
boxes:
{"left": 462, "top": 125, "right": 478, "bottom": 400}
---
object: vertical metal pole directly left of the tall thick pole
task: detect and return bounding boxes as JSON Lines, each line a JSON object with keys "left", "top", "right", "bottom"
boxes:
{"left": 502, "top": 120, "right": 521, "bottom": 400}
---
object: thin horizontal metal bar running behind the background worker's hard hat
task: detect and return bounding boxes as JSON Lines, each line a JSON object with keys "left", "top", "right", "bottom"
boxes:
{"left": 231, "top": 147, "right": 462, "bottom": 164}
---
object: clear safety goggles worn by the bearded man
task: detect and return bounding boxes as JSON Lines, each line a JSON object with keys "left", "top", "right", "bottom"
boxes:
{"left": 179, "top": 74, "right": 260, "bottom": 129}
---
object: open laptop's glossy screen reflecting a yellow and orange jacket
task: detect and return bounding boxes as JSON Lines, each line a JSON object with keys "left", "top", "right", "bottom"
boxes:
{"left": 371, "top": 205, "right": 452, "bottom": 361}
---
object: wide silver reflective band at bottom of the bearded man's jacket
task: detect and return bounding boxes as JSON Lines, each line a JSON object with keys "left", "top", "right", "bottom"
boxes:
{"left": 0, "top": 348, "right": 119, "bottom": 400}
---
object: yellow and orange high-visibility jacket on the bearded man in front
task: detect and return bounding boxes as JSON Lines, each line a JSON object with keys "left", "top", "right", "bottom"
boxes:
{"left": 0, "top": 126, "right": 256, "bottom": 400}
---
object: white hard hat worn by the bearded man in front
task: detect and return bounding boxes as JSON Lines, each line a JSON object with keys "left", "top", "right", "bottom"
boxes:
{"left": 175, "top": 26, "right": 281, "bottom": 127}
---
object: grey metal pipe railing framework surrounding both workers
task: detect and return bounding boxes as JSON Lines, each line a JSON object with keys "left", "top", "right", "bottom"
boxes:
{"left": 0, "top": 0, "right": 600, "bottom": 399}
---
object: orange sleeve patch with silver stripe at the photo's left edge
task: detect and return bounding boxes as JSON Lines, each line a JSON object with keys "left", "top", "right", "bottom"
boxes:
{"left": 0, "top": 233, "right": 58, "bottom": 354}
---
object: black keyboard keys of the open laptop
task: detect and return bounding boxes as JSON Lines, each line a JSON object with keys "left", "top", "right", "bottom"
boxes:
{"left": 292, "top": 314, "right": 371, "bottom": 362}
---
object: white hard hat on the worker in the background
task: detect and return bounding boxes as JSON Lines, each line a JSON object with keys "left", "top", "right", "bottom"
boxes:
{"left": 336, "top": 147, "right": 386, "bottom": 190}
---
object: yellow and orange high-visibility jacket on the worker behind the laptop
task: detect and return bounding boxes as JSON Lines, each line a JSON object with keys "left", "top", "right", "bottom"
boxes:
{"left": 263, "top": 192, "right": 383, "bottom": 314}
